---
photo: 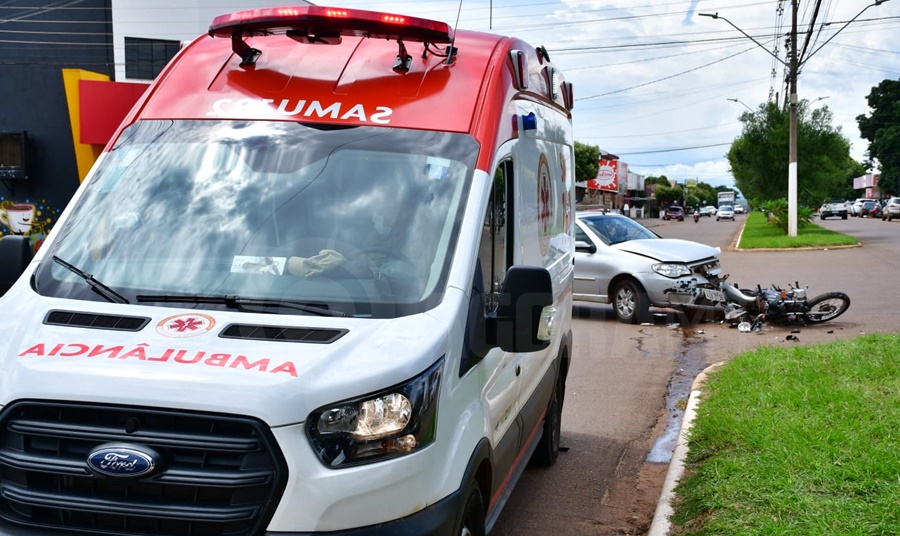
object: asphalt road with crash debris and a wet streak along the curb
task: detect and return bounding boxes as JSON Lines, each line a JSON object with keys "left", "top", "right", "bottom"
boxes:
{"left": 492, "top": 211, "right": 900, "bottom": 536}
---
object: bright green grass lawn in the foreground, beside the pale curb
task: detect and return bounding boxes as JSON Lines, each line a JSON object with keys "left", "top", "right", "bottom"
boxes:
{"left": 669, "top": 334, "right": 900, "bottom": 536}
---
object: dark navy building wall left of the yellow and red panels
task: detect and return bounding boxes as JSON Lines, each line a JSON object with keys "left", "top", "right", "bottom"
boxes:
{"left": 0, "top": 0, "right": 115, "bottom": 246}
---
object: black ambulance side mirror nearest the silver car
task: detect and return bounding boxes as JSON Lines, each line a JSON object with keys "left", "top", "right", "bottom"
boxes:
{"left": 487, "top": 266, "right": 553, "bottom": 352}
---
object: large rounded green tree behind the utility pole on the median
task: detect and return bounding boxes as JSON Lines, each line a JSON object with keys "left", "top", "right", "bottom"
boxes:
{"left": 727, "top": 100, "right": 853, "bottom": 205}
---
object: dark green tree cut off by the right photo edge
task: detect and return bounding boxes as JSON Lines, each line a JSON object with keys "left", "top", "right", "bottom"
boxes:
{"left": 856, "top": 79, "right": 900, "bottom": 195}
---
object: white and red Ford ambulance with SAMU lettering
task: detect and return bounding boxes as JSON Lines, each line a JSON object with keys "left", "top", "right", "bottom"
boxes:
{"left": 0, "top": 6, "right": 575, "bottom": 536}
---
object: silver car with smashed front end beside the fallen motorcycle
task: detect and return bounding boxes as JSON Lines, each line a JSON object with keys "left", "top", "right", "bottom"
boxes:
{"left": 574, "top": 212, "right": 724, "bottom": 324}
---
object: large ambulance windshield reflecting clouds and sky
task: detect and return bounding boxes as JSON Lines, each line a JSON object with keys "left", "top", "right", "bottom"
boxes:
{"left": 35, "top": 121, "right": 478, "bottom": 317}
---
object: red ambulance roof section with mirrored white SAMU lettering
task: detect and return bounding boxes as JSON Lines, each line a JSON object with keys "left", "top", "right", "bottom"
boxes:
{"left": 132, "top": 6, "right": 565, "bottom": 132}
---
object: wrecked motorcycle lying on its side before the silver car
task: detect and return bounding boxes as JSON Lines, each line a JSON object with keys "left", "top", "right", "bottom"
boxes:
{"left": 719, "top": 281, "right": 850, "bottom": 332}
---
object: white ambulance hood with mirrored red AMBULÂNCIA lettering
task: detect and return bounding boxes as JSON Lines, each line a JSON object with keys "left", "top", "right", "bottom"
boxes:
{"left": 0, "top": 285, "right": 446, "bottom": 426}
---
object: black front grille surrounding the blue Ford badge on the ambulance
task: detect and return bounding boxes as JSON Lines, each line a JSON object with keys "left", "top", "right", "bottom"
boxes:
{"left": 0, "top": 401, "right": 287, "bottom": 536}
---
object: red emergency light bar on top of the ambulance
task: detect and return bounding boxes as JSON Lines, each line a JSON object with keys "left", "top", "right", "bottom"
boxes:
{"left": 209, "top": 6, "right": 453, "bottom": 44}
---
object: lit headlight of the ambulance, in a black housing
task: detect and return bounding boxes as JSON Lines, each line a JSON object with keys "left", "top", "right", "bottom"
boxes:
{"left": 306, "top": 359, "right": 444, "bottom": 468}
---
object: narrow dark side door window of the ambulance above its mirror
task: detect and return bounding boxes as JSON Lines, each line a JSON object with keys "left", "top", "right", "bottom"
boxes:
{"left": 479, "top": 160, "right": 513, "bottom": 313}
